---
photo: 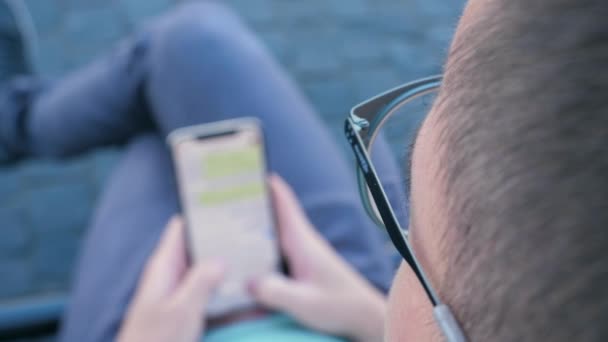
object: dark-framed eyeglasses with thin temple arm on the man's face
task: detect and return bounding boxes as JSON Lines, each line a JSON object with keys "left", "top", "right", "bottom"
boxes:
{"left": 344, "top": 76, "right": 466, "bottom": 342}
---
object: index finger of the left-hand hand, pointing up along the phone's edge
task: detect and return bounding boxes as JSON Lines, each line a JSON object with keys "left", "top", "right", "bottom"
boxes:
{"left": 140, "top": 216, "right": 187, "bottom": 298}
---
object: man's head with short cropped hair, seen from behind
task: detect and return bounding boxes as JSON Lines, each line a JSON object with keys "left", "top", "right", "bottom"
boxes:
{"left": 389, "top": 0, "right": 608, "bottom": 341}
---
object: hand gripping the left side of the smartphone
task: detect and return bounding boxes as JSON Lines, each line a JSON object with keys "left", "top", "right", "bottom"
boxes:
{"left": 118, "top": 218, "right": 223, "bottom": 342}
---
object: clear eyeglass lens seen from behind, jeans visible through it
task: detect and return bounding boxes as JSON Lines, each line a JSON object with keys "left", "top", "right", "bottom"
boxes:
{"left": 363, "top": 93, "right": 435, "bottom": 230}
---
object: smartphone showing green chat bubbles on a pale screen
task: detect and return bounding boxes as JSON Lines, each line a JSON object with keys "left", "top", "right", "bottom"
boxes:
{"left": 167, "top": 118, "right": 281, "bottom": 317}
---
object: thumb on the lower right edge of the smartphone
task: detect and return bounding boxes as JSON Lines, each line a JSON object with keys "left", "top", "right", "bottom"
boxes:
{"left": 250, "top": 274, "right": 317, "bottom": 318}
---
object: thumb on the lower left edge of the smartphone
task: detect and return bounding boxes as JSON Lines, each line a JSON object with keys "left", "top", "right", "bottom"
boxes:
{"left": 174, "top": 261, "right": 224, "bottom": 316}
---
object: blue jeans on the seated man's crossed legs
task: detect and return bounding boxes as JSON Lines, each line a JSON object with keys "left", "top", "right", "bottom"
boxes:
{"left": 0, "top": 2, "right": 408, "bottom": 341}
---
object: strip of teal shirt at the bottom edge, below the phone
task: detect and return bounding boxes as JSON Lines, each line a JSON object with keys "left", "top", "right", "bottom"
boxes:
{"left": 203, "top": 315, "right": 346, "bottom": 342}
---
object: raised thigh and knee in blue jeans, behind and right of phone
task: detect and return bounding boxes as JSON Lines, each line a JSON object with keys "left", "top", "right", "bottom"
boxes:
{"left": 146, "top": 2, "right": 398, "bottom": 289}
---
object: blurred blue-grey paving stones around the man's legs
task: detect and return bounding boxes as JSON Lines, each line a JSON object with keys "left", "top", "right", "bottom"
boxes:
{"left": 0, "top": 0, "right": 463, "bottom": 340}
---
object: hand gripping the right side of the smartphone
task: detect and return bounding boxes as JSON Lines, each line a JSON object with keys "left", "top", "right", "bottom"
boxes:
{"left": 252, "top": 176, "right": 386, "bottom": 342}
